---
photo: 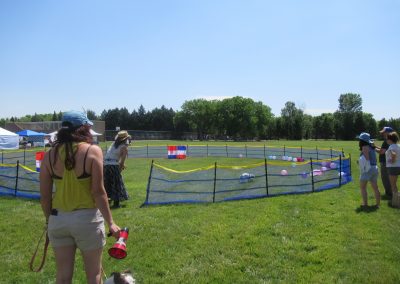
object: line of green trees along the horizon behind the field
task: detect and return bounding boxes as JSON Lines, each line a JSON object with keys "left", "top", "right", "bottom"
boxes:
{"left": 0, "top": 93, "right": 400, "bottom": 140}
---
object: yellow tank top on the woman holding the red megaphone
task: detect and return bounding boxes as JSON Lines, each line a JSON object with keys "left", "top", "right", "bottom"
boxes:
{"left": 50, "top": 143, "right": 96, "bottom": 211}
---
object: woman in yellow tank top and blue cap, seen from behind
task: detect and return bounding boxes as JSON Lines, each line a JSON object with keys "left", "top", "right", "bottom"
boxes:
{"left": 40, "top": 111, "right": 120, "bottom": 283}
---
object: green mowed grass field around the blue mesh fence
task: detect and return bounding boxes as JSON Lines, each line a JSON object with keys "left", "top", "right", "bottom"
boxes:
{"left": 0, "top": 141, "right": 400, "bottom": 283}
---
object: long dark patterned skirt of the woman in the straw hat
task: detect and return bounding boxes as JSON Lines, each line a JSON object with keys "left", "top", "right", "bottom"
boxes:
{"left": 104, "top": 165, "right": 129, "bottom": 201}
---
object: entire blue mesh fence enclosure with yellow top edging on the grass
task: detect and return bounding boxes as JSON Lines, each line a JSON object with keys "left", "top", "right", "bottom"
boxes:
{"left": 0, "top": 144, "right": 351, "bottom": 204}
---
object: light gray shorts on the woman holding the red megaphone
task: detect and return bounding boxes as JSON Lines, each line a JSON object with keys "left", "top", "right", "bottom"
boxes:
{"left": 47, "top": 208, "right": 106, "bottom": 251}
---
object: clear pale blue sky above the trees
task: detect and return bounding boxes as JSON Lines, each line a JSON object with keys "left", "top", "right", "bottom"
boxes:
{"left": 0, "top": 0, "right": 400, "bottom": 119}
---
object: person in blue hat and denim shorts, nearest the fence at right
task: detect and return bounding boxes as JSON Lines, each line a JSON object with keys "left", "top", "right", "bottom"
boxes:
{"left": 358, "top": 132, "right": 381, "bottom": 209}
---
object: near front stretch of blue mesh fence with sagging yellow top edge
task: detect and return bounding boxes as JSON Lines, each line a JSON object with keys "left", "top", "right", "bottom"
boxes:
{"left": 143, "top": 156, "right": 352, "bottom": 205}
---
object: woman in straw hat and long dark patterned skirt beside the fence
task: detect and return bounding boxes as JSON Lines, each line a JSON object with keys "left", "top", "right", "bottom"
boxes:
{"left": 104, "top": 130, "right": 131, "bottom": 208}
